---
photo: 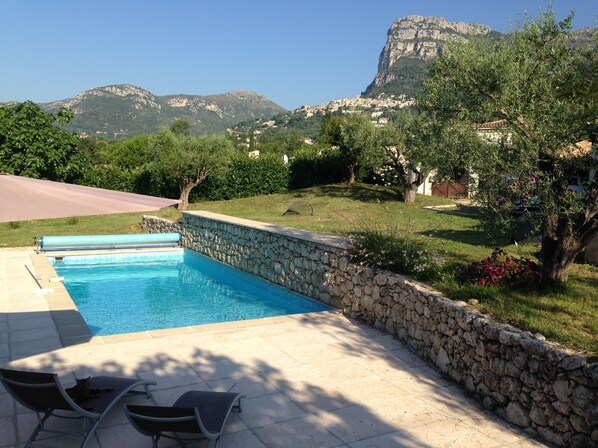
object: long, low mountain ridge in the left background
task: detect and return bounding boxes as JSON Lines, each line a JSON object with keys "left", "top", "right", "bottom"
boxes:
{"left": 40, "top": 84, "right": 286, "bottom": 138}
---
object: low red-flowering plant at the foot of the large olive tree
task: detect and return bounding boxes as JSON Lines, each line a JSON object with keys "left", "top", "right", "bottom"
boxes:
{"left": 457, "top": 249, "right": 541, "bottom": 287}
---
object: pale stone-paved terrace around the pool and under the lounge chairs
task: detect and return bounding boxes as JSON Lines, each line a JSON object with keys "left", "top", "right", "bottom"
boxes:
{"left": 0, "top": 250, "right": 544, "bottom": 448}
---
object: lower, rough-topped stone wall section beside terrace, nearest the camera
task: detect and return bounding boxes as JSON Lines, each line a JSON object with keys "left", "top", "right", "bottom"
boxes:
{"left": 329, "top": 265, "right": 598, "bottom": 447}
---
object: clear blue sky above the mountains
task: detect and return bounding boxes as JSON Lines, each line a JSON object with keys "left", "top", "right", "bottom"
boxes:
{"left": 0, "top": 0, "right": 598, "bottom": 109}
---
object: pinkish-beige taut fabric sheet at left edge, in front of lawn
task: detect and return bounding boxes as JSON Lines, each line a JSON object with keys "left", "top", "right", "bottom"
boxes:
{"left": 0, "top": 173, "right": 180, "bottom": 222}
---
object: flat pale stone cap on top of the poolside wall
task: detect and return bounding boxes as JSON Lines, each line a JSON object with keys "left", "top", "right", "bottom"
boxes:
{"left": 183, "top": 211, "right": 350, "bottom": 249}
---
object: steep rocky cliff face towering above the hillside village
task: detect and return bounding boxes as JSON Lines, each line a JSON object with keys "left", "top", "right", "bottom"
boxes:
{"left": 364, "top": 16, "right": 492, "bottom": 96}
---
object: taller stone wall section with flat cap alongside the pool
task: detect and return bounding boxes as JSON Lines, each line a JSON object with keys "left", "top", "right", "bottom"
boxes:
{"left": 183, "top": 212, "right": 349, "bottom": 308}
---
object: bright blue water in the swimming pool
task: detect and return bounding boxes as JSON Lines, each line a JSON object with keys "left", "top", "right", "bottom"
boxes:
{"left": 50, "top": 250, "right": 330, "bottom": 336}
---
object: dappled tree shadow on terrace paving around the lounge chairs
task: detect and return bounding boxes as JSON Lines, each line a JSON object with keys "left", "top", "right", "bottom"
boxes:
{"left": 0, "top": 350, "right": 432, "bottom": 448}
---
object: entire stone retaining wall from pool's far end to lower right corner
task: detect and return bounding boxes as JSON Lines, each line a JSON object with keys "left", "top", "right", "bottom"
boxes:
{"left": 144, "top": 212, "right": 598, "bottom": 447}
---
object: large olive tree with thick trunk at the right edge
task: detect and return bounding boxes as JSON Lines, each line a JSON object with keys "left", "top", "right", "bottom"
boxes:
{"left": 421, "top": 10, "right": 598, "bottom": 284}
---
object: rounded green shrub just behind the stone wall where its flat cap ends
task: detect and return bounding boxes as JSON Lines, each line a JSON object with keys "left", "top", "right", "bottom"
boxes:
{"left": 351, "top": 220, "right": 442, "bottom": 280}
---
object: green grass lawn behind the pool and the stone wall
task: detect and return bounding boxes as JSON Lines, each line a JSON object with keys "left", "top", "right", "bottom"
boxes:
{"left": 0, "top": 185, "right": 598, "bottom": 354}
